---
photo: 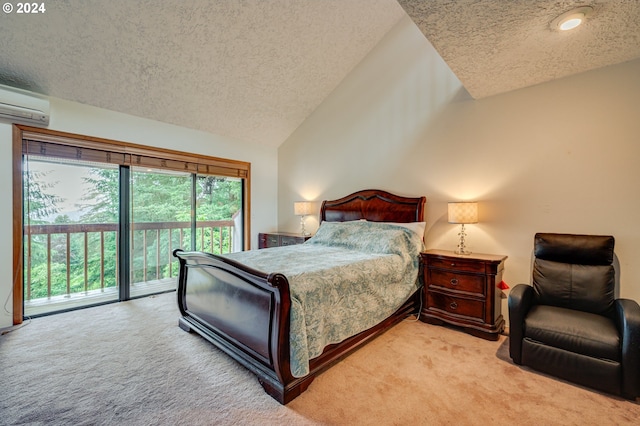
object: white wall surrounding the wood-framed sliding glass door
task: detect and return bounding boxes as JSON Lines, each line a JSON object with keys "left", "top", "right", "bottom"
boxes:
{"left": 0, "top": 98, "right": 278, "bottom": 328}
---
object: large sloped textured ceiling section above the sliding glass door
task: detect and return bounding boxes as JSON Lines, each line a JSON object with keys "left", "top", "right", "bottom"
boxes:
{"left": 0, "top": 0, "right": 406, "bottom": 146}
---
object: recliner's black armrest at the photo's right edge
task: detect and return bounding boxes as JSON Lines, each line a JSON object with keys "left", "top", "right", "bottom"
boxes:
{"left": 615, "top": 299, "right": 640, "bottom": 399}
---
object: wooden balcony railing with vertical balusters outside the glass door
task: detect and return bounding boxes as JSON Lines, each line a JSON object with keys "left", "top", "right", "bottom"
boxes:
{"left": 24, "top": 221, "right": 241, "bottom": 301}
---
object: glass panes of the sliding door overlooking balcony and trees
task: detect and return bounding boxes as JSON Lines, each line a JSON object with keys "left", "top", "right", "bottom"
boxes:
{"left": 24, "top": 160, "right": 243, "bottom": 316}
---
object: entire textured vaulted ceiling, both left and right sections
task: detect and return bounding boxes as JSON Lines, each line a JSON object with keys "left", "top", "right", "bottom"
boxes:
{"left": 0, "top": 0, "right": 640, "bottom": 146}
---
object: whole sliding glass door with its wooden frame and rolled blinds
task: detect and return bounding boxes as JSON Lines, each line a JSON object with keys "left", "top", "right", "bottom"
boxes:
{"left": 13, "top": 126, "right": 250, "bottom": 323}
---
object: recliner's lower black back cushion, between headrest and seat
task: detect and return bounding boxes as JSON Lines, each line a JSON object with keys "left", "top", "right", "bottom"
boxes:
{"left": 533, "top": 258, "right": 615, "bottom": 317}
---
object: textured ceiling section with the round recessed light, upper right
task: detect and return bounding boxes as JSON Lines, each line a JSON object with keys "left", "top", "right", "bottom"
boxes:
{"left": 398, "top": 0, "right": 640, "bottom": 99}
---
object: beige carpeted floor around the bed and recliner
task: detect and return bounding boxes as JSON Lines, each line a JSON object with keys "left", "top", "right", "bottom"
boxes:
{"left": 0, "top": 293, "right": 640, "bottom": 425}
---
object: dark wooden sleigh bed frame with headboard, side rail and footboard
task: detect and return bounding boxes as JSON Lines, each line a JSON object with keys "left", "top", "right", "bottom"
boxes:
{"left": 174, "top": 190, "right": 426, "bottom": 404}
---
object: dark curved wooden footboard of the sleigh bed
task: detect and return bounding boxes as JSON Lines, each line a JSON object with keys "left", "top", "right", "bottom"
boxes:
{"left": 174, "top": 250, "right": 312, "bottom": 404}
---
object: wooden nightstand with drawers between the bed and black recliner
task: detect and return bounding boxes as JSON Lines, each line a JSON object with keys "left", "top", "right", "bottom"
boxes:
{"left": 420, "top": 250, "right": 507, "bottom": 340}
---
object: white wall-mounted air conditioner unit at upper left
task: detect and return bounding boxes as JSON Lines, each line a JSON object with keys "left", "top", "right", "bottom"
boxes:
{"left": 0, "top": 84, "right": 49, "bottom": 126}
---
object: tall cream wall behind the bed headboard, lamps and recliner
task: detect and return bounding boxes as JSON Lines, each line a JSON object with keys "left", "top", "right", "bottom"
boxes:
{"left": 278, "top": 18, "right": 640, "bottom": 317}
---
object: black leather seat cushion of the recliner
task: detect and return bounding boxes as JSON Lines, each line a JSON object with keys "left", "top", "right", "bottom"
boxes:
{"left": 524, "top": 305, "right": 621, "bottom": 362}
